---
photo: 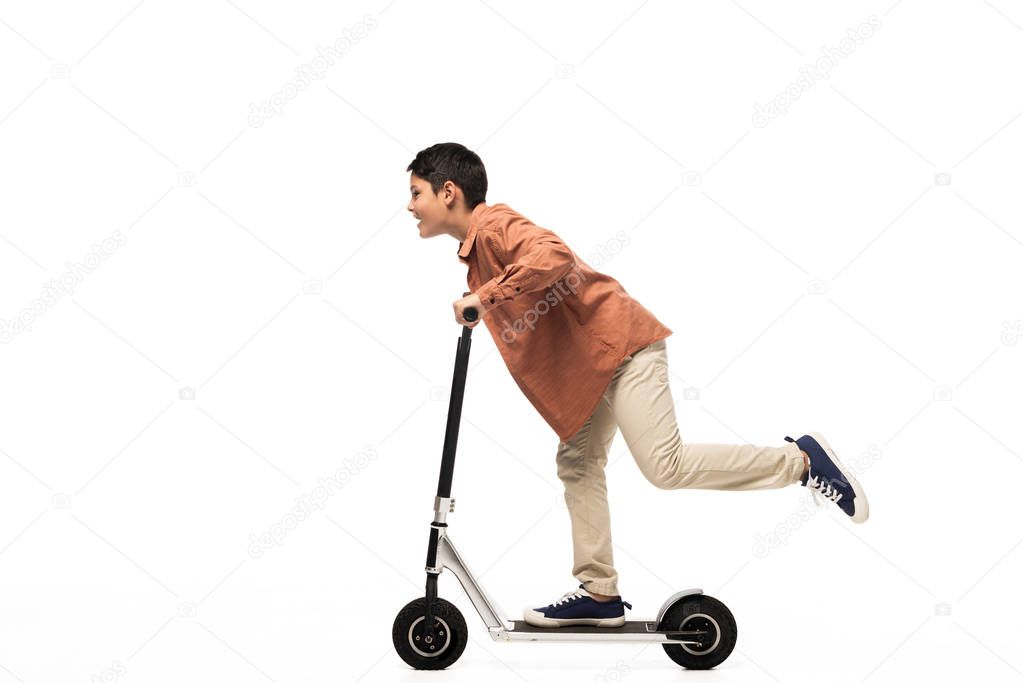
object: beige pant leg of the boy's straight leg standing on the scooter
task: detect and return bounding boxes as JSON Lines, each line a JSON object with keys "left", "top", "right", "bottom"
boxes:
{"left": 557, "top": 382, "right": 618, "bottom": 595}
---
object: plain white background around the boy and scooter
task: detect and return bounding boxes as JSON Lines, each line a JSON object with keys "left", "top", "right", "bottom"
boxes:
{"left": 0, "top": 0, "right": 1023, "bottom": 683}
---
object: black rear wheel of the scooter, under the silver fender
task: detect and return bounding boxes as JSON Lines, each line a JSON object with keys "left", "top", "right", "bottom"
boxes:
{"left": 658, "top": 594, "right": 738, "bottom": 669}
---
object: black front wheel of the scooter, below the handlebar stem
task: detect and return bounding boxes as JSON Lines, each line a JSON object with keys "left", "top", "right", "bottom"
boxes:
{"left": 391, "top": 597, "right": 469, "bottom": 669}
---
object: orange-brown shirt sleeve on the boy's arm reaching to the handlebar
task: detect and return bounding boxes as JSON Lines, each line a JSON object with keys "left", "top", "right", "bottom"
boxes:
{"left": 476, "top": 217, "right": 575, "bottom": 311}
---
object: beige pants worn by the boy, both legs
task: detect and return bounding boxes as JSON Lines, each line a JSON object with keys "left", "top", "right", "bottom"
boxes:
{"left": 558, "top": 339, "right": 803, "bottom": 595}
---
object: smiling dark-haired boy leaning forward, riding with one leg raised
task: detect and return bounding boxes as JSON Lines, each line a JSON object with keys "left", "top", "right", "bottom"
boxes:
{"left": 406, "top": 142, "right": 869, "bottom": 627}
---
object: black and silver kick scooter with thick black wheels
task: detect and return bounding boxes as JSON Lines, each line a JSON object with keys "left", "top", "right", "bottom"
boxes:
{"left": 391, "top": 308, "right": 737, "bottom": 669}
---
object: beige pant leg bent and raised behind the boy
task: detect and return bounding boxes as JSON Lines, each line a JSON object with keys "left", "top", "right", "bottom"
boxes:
{"left": 606, "top": 339, "right": 803, "bottom": 491}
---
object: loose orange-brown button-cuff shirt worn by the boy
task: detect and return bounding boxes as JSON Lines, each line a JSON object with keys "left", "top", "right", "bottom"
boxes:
{"left": 458, "top": 202, "right": 672, "bottom": 441}
